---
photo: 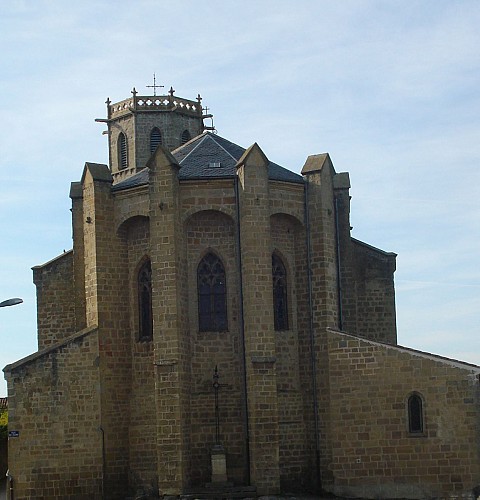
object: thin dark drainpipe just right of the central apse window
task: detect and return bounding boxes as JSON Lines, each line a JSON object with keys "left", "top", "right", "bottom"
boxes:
{"left": 234, "top": 175, "right": 250, "bottom": 486}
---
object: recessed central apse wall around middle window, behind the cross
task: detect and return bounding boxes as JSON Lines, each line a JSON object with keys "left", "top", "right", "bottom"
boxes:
{"left": 186, "top": 209, "right": 246, "bottom": 485}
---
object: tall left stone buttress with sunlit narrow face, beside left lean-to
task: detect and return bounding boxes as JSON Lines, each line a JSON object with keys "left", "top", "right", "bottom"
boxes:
{"left": 83, "top": 165, "right": 131, "bottom": 498}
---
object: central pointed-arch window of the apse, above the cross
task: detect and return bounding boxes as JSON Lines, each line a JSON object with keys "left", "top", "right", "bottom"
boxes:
{"left": 197, "top": 253, "right": 227, "bottom": 332}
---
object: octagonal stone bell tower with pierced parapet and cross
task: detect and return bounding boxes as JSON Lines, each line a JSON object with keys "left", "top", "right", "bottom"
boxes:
{"left": 95, "top": 82, "right": 214, "bottom": 183}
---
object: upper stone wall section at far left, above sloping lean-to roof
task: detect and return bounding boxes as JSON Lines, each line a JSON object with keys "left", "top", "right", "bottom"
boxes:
{"left": 33, "top": 251, "right": 75, "bottom": 349}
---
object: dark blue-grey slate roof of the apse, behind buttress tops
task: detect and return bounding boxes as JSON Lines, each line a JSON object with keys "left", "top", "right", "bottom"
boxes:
{"left": 112, "top": 132, "right": 303, "bottom": 191}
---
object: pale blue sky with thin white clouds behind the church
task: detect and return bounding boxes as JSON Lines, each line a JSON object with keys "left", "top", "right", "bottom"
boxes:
{"left": 0, "top": 0, "right": 480, "bottom": 397}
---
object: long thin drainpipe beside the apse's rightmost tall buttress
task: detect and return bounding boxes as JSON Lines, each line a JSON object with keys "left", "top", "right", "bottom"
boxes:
{"left": 304, "top": 181, "right": 322, "bottom": 491}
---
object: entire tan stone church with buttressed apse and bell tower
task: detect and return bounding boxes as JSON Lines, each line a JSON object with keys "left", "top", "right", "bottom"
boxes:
{"left": 4, "top": 88, "right": 480, "bottom": 499}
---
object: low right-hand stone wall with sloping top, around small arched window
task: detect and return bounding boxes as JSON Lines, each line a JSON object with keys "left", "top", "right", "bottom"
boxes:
{"left": 328, "top": 331, "right": 480, "bottom": 498}
